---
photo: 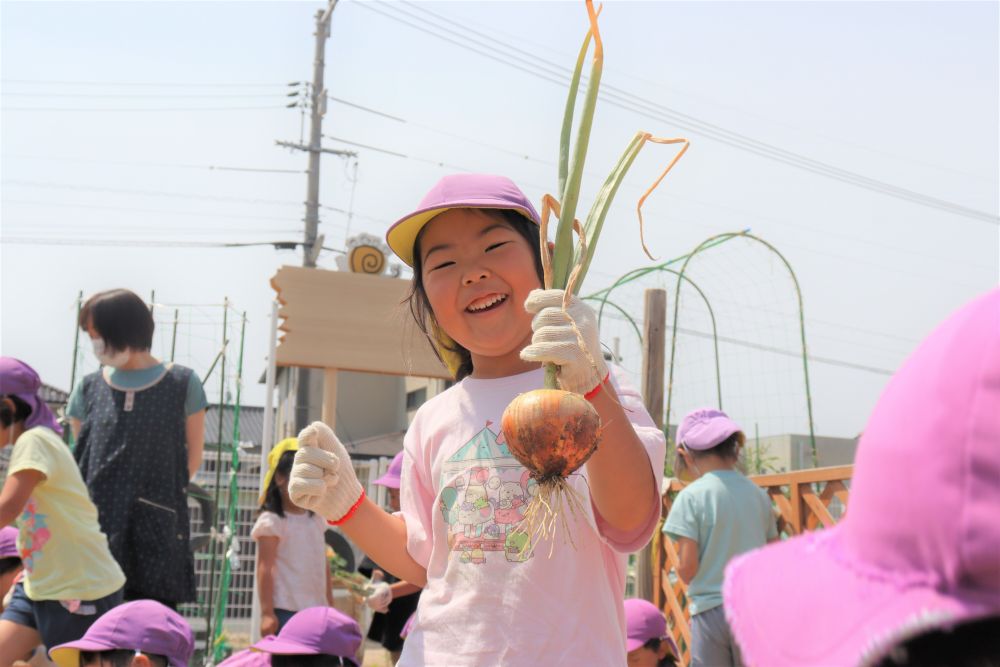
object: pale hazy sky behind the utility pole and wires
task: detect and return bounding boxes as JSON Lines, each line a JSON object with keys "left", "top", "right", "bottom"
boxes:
{"left": 0, "top": 1, "right": 1000, "bottom": 435}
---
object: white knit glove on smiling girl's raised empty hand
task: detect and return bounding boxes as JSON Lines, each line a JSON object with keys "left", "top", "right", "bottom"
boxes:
{"left": 288, "top": 422, "right": 364, "bottom": 522}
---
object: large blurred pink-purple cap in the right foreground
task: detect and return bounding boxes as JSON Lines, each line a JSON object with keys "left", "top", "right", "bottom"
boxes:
{"left": 722, "top": 289, "right": 1000, "bottom": 667}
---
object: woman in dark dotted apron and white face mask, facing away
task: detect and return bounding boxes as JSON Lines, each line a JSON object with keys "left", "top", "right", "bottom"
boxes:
{"left": 67, "top": 289, "right": 207, "bottom": 608}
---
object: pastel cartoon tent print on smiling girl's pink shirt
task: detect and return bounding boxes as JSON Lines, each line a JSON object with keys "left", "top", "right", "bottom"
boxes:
{"left": 440, "top": 421, "right": 537, "bottom": 564}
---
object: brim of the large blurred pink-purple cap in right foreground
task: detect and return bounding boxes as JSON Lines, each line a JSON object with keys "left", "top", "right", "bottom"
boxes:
{"left": 722, "top": 524, "right": 983, "bottom": 667}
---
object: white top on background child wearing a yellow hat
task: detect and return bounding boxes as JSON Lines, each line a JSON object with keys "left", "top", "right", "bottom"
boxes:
{"left": 250, "top": 512, "right": 327, "bottom": 611}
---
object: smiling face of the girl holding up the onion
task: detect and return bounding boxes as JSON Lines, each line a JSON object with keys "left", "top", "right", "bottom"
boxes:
{"left": 419, "top": 209, "right": 541, "bottom": 377}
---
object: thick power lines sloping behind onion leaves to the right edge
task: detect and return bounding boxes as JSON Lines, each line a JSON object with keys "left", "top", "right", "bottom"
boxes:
{"left": 359, "top": 3, "right": 1000, "bottom": 224}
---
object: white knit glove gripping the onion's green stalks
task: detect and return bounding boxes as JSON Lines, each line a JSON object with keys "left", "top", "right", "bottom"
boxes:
{"left": 521, "top": 289, "right": 608, "bottom": 394}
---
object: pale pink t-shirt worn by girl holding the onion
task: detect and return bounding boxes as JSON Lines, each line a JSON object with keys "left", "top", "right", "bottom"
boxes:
{"left": 398, "top": 369, "right": 665, "bottom": 667}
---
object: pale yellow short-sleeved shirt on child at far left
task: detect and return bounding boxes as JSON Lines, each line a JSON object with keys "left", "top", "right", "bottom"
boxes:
{"left": 7, "top": 426, "right": 125, "bottom": 600}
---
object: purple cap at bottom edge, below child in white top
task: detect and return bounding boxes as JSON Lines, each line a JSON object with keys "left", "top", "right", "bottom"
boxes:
{"left": 253, "top": 607, "right": 361, "bottom": 660}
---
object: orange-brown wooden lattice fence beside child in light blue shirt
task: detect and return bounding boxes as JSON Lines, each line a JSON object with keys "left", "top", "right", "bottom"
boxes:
{"left": 653, "top": 466, "right": 854, "bottom": 665}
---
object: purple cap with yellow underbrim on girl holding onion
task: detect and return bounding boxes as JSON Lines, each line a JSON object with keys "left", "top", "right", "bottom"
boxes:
{"left": 385, "top": 174, "right": 538, "bottom": 266}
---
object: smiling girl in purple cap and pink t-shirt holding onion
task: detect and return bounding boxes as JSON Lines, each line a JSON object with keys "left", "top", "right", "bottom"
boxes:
{"left": 289, "top": 174, "right": 664, "bottom": 667}
